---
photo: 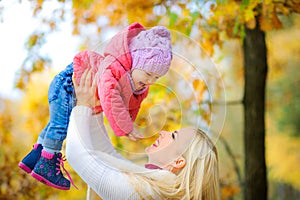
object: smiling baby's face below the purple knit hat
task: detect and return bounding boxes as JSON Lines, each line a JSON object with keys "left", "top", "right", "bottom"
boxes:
{"left": 131, "top": 69, "right": 160, "bottom": 90}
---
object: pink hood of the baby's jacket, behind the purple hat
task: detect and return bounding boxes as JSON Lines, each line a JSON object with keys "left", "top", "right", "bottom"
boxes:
{"left": 104, "top": 22, "right": 146, "bottom": 71}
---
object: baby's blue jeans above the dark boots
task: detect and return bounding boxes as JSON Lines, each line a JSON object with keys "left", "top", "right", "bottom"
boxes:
{"left": 39, "top": 63, "right": 76, "bottom": 151}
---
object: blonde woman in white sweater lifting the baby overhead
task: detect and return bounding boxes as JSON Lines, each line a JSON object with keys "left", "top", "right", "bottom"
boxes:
{"left": 66, "top": 71, "right": 219, "bottom": 200}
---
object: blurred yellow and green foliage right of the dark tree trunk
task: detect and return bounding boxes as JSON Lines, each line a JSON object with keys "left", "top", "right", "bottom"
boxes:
{"left": 266, "top": 16, "right": 300, "bottom": 190}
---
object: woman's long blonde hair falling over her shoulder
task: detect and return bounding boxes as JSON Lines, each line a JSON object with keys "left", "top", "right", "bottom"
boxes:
{"left": 128, "top": 129, "right": 219, "bottom": 200}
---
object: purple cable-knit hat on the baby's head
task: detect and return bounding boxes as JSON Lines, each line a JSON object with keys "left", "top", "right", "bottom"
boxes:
{"left": 129, "top": 26, "right": 172, "bottom": 76}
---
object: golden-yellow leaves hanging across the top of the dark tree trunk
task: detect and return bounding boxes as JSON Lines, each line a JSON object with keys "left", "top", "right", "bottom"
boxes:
{"left": 207, "top": 0, "right": 300, "bottom": 52}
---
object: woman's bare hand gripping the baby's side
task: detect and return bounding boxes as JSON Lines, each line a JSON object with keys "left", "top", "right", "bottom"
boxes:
{"left": 72, "top": 69, "right": 99, "bottom": 108}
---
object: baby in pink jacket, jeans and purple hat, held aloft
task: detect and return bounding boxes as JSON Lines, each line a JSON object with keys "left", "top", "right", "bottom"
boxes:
{"left": 19, "top": 23, "right": 172, "bottom": 190}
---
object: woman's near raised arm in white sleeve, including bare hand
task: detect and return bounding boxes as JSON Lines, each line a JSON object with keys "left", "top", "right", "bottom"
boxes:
{"left": 66, "top": 70, "right": 136, "bottom": 199}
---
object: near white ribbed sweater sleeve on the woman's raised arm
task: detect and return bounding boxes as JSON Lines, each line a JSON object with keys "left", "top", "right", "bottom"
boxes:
{"left": 66, "top": 106, "right": 137, "bottom": 200}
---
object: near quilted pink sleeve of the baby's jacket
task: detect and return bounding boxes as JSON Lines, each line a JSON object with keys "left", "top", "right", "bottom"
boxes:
{"left": 98, "top": 69, "right": 133, "bottom": 136}
